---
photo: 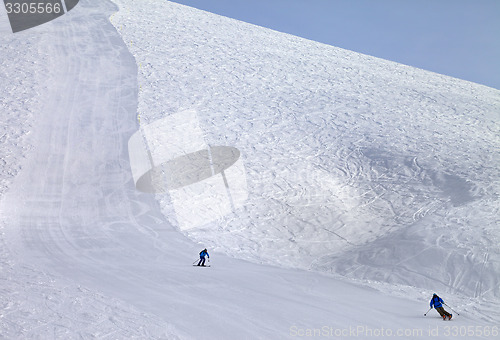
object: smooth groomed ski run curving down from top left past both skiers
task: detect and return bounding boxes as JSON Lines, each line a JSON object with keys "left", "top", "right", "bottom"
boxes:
{"left": 0, "top": 1, "right": 498, "bottom": 339}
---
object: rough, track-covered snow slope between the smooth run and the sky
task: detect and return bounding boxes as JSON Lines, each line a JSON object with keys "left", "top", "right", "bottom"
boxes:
{"left": 113, "top": 1, "right": 500, "bottom": 297}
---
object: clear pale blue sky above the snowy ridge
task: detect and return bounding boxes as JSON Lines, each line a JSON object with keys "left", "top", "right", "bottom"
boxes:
{"left": 174, "top": 0, "right": 500, "bottom": 89}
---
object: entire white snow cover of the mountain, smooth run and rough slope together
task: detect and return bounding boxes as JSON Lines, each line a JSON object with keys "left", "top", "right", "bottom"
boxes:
{"left": 0, "top": 0, "right": 500, "bottom": 339}
